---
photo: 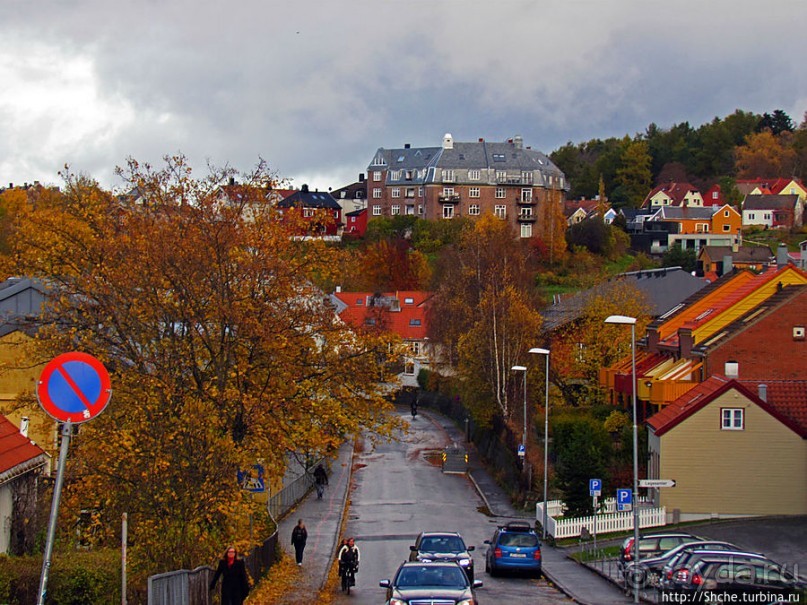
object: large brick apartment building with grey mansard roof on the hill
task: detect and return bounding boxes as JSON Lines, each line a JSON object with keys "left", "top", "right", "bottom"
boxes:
{"left": 367, "top": 134, "right": 569, "bottom": 237}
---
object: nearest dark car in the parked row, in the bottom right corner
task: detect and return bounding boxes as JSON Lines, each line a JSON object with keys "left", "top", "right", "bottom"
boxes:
{"left": 664, "top": 556, "right": 807, "bottom": 603}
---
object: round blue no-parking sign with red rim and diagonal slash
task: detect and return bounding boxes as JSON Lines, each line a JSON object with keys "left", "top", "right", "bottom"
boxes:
{"left": 36, "top": 351, "right": 112, "bottom": 424}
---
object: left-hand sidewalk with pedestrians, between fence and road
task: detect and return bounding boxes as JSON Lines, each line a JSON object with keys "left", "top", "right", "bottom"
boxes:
{"left": 278, "top": 443, "right": 353, "bottom": 603}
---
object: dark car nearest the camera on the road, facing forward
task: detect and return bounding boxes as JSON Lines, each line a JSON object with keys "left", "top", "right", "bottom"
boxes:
{"left": 378, "top": 561, "right": 482, "bottom": 605}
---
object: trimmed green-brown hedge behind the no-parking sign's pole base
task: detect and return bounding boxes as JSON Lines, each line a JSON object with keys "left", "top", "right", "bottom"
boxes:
{"left": 0, "top": 549, "right": 121, "bottom": 605}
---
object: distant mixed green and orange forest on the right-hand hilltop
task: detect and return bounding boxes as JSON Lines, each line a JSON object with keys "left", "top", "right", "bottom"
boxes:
{"left": 550, "top": 109, "right": 807, "bottom": 208}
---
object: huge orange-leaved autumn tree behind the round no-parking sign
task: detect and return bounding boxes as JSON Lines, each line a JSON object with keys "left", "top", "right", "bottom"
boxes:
{"left": 5, "top": 156, "right": 392, "bottom": 577}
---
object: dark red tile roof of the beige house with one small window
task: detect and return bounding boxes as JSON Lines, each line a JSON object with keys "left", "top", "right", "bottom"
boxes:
{"left": 647, "top": 374, "right": 807, "bottom": 439}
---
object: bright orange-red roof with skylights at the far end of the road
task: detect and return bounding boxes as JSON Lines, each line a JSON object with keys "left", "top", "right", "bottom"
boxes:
{"left": 333, "top": 290, "right": 433, "bottom": 340}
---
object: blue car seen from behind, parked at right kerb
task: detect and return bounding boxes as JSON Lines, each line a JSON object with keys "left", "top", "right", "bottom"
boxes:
{"left": 485, "top": 522, "right": 541, "bottom": 577}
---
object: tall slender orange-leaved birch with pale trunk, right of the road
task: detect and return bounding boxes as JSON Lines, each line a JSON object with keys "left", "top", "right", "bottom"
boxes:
{"left": 429, "top": 214, "right": 541, "bottom": 422}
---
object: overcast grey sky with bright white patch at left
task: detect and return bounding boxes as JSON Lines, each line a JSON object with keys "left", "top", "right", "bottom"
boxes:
{"left": 0, "top": 0, "right": 807, "bottom": 190}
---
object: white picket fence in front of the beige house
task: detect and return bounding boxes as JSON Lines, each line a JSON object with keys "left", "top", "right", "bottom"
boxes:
{"left": 535, "top": 498, "right": 667, "bottom": 540}
